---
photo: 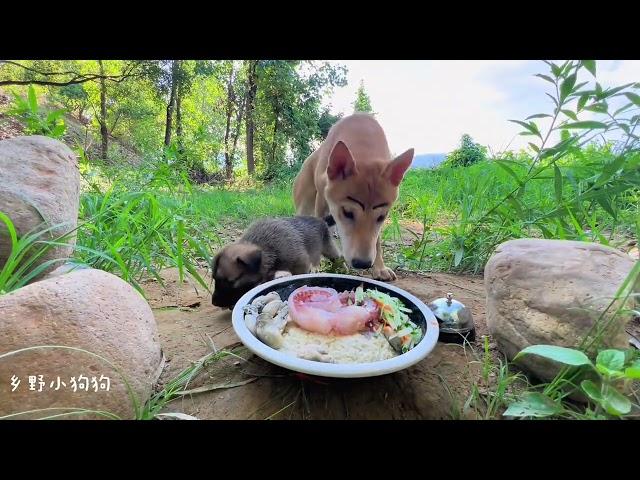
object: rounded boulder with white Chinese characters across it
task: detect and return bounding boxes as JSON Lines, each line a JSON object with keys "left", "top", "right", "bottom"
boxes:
{"left": 0, "top": 269, "right": 164, "bottom": 418}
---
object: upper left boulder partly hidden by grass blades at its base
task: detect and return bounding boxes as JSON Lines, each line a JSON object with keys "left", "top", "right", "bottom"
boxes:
{"left": 0, "top": 136, "right": 80, "bottom": 276}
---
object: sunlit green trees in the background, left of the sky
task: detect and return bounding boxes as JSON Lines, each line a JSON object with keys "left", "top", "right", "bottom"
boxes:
{"left": 0, "top": 60, "right": 346, "bottom": 181}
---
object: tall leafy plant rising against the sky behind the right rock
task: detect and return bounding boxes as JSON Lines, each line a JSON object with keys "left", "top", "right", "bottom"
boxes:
{"left": 478, "top": 60, "right": 640, "bottom": 244}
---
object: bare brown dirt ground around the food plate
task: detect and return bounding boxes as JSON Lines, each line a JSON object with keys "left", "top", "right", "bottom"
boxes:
{"left": 144, "top": 270, "right": 497, "bottom": 419}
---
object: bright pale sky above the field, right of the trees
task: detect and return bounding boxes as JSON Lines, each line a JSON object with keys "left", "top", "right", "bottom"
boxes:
{"left": 324, "top": 60, "right": 640, "bottom": 154}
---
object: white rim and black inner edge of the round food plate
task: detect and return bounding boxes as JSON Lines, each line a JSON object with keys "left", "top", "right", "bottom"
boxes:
{"left": 232, "top": 273, "right": 439, "bottom": 378}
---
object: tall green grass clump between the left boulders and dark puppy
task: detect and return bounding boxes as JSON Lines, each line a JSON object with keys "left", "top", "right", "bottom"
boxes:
{"left": 76, "top": 187, "right": 211, "bottom": 292}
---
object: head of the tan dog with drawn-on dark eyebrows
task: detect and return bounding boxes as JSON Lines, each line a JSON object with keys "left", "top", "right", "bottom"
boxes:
{"left": 326, "top": 141, "right": 413, "bottom": 269}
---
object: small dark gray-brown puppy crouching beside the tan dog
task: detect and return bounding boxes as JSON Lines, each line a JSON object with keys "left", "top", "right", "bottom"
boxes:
{"left": 211, "top": 216, "right": 340, "bottom": 308}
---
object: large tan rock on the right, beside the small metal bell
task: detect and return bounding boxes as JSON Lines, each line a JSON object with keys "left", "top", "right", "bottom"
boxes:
{"left": 484, "top": 239, "right": 634, "bottom": 381}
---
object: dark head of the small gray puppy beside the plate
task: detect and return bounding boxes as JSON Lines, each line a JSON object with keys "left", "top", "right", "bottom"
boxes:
{"left": 211, "top": 243, "right": 263, "bottom": 309}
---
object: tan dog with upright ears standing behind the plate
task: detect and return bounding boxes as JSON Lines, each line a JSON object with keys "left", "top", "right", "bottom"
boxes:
{"left": 294, "top": 113, "right": 413, "bottom": 281}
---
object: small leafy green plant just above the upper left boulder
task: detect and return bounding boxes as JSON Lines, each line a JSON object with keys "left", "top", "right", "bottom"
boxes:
{"left": 7, "top": 85, "right": 66, "bottom": 138}
